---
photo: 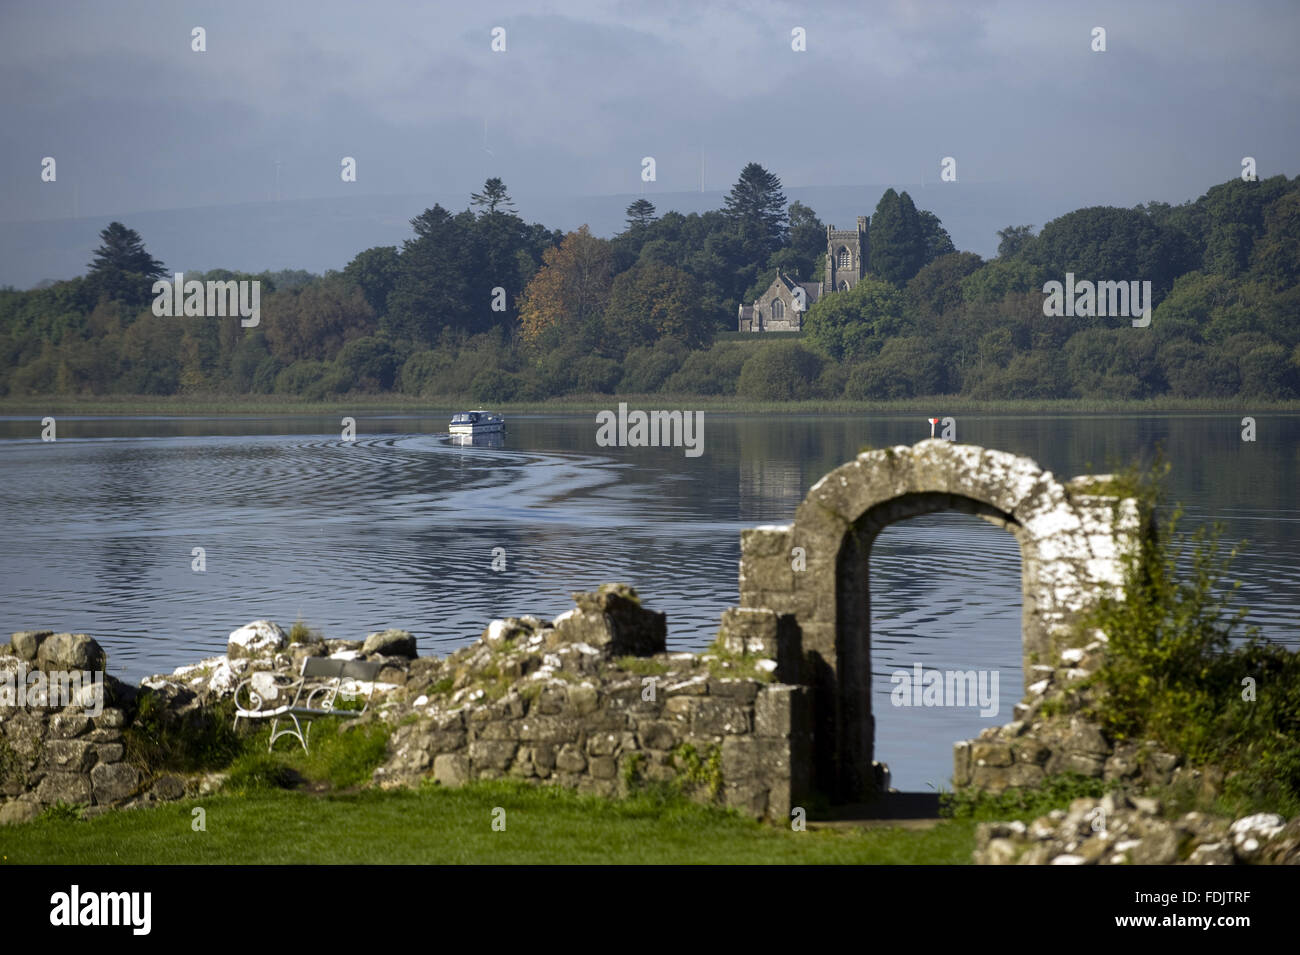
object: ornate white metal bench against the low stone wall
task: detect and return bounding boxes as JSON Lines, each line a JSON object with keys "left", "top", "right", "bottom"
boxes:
{"left": 235, "top": 656, "right": 384, "bottom": 752}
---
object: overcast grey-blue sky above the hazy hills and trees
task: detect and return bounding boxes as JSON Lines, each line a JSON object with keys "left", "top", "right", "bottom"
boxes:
{"left": 0, "top": 0, "right": 1300, "bottom": 225}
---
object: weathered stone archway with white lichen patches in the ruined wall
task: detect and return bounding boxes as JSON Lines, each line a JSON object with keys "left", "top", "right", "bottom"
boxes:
{"left": 740, "top": 439, "right": 1140, "bottom": 802}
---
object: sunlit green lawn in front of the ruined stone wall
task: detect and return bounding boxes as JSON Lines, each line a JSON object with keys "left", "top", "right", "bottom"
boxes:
{"left": 0, "top": 782, "right": 975, "bottom": 865}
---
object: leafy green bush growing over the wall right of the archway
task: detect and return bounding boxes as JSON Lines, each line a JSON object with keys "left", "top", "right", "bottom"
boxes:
{"left": 1087, "top": 454, "right": 1300, "bottom": 815}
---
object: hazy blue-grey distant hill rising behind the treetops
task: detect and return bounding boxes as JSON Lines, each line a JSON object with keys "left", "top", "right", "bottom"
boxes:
{"left": 0, "top": 182, "right": 1079, "bottom": 288}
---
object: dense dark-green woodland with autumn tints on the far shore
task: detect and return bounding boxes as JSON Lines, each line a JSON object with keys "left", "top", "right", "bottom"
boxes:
{"left": 0, "top": 162, "right": 1300, "bottom": 403}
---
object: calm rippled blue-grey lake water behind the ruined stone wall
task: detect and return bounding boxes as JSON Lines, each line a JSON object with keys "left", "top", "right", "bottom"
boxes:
{"left": 0, "top": 409, "right": 1300, "bottom": 790}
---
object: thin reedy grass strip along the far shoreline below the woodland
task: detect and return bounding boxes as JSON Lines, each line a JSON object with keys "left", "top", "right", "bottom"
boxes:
{"left": 0, "top": 394, "right": 1300, "bottom": 416}
